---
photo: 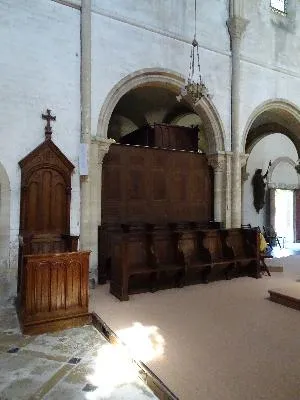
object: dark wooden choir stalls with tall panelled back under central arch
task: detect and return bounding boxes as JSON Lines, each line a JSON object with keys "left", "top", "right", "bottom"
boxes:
{"left": 98, "top": 124, "right": 259, "bottom": 300}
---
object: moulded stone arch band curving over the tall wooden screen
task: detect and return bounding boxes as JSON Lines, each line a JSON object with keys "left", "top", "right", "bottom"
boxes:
{"left": 97, "top": 68, "right": 225, "bottom": 153}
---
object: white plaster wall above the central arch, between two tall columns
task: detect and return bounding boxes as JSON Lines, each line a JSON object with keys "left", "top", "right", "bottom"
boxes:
{"left": 92, "top": 0, "right": 231, "bottom": 150}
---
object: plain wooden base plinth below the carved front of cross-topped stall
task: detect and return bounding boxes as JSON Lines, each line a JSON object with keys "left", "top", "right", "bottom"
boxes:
{"left": 20, "top": 313, "right": 92, "bottom": 335}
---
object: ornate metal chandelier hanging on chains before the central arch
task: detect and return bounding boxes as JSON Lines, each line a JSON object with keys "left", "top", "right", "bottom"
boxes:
{"left": 176, "top": 0, "right": 210, "bottom": 104}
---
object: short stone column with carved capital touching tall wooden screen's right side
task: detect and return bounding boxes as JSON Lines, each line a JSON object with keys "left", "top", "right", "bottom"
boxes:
{"left": 207, "top": 152, "right": 225, "bottom": 222}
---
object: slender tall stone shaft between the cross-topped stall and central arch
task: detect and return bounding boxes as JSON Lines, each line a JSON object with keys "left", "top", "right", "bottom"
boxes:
{"left": 80, "top": 0, "right": 91, "bottom": 253}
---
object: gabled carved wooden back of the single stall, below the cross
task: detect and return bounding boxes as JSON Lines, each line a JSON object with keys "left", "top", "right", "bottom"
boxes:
{"left": 19, "top": 140, "right": 74, "bottom": 236}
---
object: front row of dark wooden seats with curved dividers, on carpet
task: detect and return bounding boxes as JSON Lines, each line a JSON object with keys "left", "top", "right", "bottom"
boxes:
{"left": 110, "top": 224, "right": 259, "bottom": 300}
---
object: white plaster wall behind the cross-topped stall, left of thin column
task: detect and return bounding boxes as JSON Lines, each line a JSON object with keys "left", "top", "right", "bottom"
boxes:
{"left": 0, "top": 0, "right": 80, "bottom": 300}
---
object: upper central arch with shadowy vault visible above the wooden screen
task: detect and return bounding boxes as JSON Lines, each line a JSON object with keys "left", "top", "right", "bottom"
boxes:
{"left": 97, "top": 68, "right": 225, "bottom": 154}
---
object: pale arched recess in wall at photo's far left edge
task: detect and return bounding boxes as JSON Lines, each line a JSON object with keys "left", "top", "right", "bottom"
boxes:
{"left": 0, "top": 163, "right": 12, "bottom": 303}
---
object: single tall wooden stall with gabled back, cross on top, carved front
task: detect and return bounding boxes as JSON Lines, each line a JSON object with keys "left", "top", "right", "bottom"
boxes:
{"left": 18, "top": 110, "right": 90, "bottom": 334}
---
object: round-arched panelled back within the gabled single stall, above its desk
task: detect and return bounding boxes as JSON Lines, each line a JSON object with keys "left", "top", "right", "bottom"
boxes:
{"left": 21, "top": 168, "right": 69, "bottom": 254}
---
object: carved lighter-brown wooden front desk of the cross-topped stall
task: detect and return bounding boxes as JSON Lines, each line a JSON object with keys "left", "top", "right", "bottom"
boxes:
{"left": 20, "top": 251, "right": 90, "bottom": 333}
